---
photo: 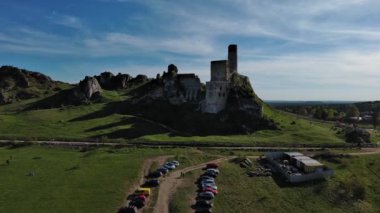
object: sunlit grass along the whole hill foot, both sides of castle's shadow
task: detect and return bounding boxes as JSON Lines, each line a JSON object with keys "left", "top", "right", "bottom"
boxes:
{"left": 0, "top": 91, "right": 366, "bottom": 146}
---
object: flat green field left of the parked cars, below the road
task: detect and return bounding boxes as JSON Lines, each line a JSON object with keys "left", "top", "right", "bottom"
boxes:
{"left": 0, "top": 146, "right": 166, "bottom": 212}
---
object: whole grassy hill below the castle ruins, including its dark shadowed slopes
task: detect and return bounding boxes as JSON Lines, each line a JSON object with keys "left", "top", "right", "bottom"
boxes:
{"left": 0, "top": 64, "right": 362, "bottom": 146}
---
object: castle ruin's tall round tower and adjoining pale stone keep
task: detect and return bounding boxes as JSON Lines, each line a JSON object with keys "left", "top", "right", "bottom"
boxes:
{"left": 202, "top": 44, "right": 237, "bottom": 114}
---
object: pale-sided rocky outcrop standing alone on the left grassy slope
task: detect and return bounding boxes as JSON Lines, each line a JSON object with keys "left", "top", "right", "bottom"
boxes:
{"left": 69, "top": 76, "right": 102, "bottom": 104}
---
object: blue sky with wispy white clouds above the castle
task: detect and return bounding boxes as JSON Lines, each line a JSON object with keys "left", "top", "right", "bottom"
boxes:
{"left": 0, "top": 0, "right": 380, "bottom": 101}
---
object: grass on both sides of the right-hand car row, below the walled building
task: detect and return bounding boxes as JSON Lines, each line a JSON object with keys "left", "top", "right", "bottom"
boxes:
{"left": 171, "top": 155, "right": 380, "bottom": 213}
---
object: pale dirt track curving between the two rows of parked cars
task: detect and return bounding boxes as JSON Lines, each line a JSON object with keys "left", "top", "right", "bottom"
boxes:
{"left": 154, "top": 156, "right": 234, "bottom": 213}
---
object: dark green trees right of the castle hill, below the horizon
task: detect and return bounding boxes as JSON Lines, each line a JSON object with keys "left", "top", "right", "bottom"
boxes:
{"left": 276, "top": 101, "right": 380, "bottom": 127}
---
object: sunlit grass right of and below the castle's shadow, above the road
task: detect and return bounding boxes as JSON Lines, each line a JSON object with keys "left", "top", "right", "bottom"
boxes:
{"left": 143, "top": 106, "right": 344, "bottom": 146}
